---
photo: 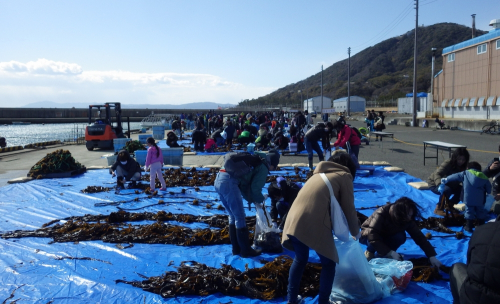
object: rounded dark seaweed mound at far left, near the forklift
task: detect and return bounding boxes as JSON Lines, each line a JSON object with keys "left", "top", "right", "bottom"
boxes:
{"left": 28, "top": 149, "right": 84, "bottom": 179}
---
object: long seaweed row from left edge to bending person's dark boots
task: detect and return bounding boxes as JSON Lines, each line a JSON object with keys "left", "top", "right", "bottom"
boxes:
{"left": 2, "top": 211, "right": 255, "bottom": 246}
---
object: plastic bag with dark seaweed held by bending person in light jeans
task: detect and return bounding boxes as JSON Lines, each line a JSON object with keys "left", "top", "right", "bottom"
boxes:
{"left": 253, "top": 205, "right": 283, "bottom": 253}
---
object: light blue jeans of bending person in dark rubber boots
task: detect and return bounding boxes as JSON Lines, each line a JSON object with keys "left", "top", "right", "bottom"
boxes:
{"left": 214, "top": 172, "right": 246, "bottom": 229}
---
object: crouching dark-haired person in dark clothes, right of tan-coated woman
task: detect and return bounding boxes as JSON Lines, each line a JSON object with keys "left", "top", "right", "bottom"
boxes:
{"left": 359, "top": 197, "right": 442, "bottom": 267}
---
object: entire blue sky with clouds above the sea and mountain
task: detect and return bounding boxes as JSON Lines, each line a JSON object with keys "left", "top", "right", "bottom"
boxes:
{"left": 0, "top": 0, "right": 500, "bottom": 107}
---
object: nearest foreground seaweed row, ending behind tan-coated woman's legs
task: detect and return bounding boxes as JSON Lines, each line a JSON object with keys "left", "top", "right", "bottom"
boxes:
{"left": 116, "top": 256, "right": 321, "bottom": 300}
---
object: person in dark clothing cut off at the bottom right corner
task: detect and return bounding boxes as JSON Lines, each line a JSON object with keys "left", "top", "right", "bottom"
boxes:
{"left": 450, "top": 216, "right": 500, "bottom": 304}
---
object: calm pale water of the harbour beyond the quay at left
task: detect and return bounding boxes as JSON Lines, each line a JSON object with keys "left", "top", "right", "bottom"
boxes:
{"left": 0, "top": 122, "right": 141, "bottom": 147}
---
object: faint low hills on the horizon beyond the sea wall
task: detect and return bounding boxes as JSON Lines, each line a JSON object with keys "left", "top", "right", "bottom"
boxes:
{"left": 23, "top": 101, "right": 236, "bottom": 110}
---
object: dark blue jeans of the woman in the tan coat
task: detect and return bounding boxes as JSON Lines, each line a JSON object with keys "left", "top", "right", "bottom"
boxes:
{"left": 287, "top": 235, "right": 336, "bottom": 304}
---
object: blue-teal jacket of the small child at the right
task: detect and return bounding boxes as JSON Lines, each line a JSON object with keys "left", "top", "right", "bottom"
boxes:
{"left": 446, "top": 169, "right": 491, "bottom": 206}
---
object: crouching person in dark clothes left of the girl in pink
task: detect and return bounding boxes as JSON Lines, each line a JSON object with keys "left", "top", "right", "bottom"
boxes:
{"left": 109, "top": 150, "right": 141, "bottom": 189}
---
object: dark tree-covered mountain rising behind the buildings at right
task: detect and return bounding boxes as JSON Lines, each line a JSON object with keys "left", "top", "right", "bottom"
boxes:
{"left": 244, "top": 23, "right": 487, "bottom": 105}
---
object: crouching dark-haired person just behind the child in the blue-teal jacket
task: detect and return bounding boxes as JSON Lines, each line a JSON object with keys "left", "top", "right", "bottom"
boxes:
{"left": 427, "top": 148, "right": 470, "bottom": 215}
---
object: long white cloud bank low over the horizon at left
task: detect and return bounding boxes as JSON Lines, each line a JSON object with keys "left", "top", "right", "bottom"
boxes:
{"left": 0, "top": 59, "right": 276, "bottom": 107}
